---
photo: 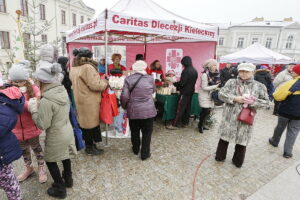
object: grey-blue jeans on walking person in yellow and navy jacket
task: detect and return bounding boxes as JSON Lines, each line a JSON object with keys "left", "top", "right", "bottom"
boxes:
{"left": 272, "top": 116, "right": 300, "bottom": 154}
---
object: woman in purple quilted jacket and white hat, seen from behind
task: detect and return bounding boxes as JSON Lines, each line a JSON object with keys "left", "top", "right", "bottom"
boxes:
{"left": 121, "top": 60, "right": 156, "bottom": 160}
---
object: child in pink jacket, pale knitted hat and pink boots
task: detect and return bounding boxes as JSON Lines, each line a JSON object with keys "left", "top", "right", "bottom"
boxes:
{"left": 9, "top": 63, "right": 47, "bottom": 183}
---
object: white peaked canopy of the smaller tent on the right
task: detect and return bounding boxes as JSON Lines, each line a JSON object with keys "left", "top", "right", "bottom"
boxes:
{"left": 220, "top": 43, "right": 293, "bottom": 64}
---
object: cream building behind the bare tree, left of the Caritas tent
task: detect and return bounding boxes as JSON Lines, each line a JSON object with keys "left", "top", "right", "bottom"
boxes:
{"left": 0, "top": 0, "right": 95, "bottom": 75}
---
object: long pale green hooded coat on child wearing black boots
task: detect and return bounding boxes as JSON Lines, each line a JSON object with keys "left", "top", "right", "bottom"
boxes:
{"left": 32, "top": 83, "right": 77, "bottom": 162}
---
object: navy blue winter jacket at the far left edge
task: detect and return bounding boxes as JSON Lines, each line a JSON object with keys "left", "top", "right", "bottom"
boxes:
{"left": 0, "top": 87, "right": 25, "bottom": 168}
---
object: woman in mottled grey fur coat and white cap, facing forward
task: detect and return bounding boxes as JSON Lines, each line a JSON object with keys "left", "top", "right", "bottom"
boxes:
{"left": 215, "top": 63, "right": 269, "bottom": 167}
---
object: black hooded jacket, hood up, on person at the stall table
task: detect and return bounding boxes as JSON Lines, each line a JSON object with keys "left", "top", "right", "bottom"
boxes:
{"left": 174, "top": 56, "right": 198, "bottom": 96}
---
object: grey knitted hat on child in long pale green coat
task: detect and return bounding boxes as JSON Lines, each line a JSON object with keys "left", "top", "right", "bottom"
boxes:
{"left": 33, "top": 63, "right": 62, "bottom": 83}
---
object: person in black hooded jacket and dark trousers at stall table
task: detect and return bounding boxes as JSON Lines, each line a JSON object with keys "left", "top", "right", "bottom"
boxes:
{"left": 168, "top": 56, "right": 198, "bottom": 129}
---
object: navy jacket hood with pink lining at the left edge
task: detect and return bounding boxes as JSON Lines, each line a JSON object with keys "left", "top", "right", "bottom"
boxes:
{"left": 0, "top": 87, "right": 25, "bottom": 114}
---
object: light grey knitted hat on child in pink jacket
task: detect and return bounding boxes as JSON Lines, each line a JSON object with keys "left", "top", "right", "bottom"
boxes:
{"left": 8, "top": 63, "right": 29, "bottom": 81}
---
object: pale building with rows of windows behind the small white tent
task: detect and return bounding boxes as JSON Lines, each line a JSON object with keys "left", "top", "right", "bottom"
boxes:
{"left": 217, "top": 18, "right": 300, "bottom": 60}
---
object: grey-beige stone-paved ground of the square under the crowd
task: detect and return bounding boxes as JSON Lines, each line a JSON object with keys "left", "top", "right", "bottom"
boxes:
{"left": 0, "top": 109, "right": 300, "bottom": 200}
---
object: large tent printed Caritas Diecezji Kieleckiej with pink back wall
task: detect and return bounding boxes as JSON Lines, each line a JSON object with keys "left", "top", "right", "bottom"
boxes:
{"left": 67, "top": 0, "right": 218, "bottom": 139}
